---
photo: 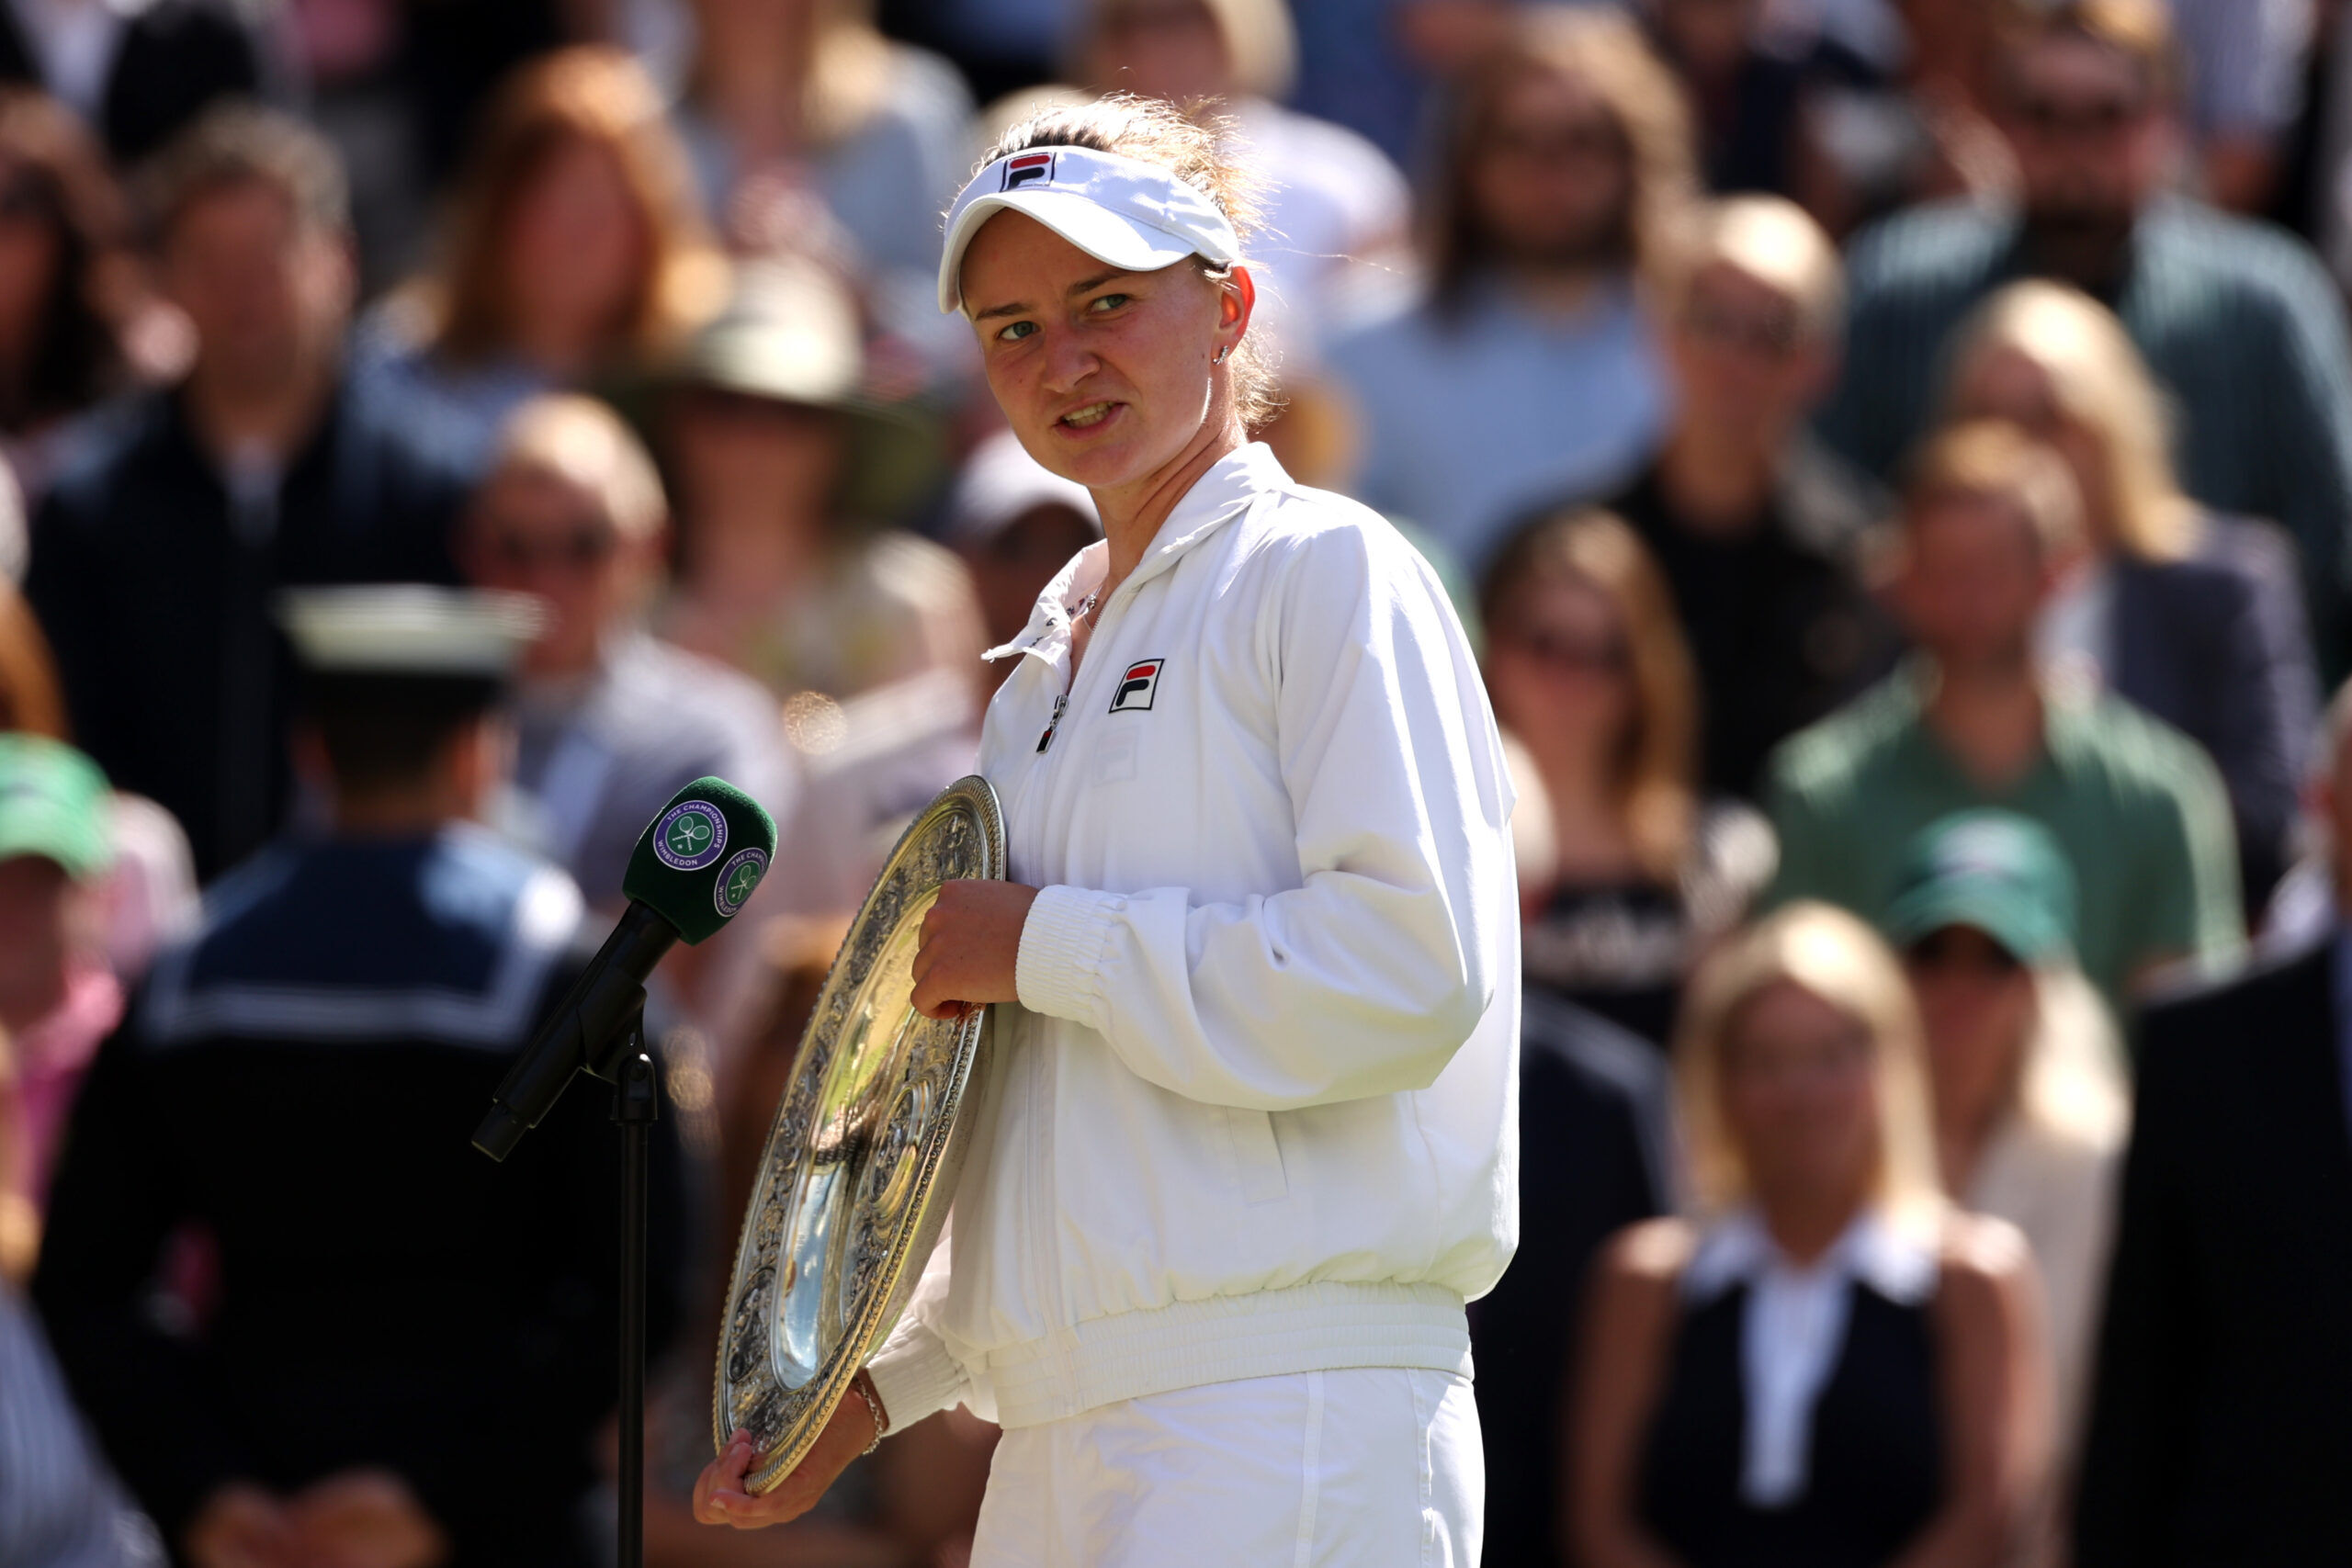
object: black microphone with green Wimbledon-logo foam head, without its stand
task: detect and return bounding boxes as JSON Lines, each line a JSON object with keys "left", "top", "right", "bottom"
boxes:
{"left": 473, "top": 778, "right": 776, "bottom": 1159}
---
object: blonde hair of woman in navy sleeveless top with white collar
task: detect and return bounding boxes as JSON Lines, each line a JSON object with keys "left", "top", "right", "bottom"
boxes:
{"left": 1675, "top": 903, "right": 1943, "bottom": 1218}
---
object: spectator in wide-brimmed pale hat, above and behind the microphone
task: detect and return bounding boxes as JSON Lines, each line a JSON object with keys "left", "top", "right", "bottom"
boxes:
{"left": 656, "top": 256, "right": 983, "bottom": 912}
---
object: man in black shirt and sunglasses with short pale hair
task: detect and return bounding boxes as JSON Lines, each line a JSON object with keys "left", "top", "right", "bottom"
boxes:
{"left": 1609, "top": 195, "right": 1895, "bottom": 797}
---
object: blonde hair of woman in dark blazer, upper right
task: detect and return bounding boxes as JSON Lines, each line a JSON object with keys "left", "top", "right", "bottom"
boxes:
{"left": 1948, "top": 280, "right": 2197, "bottom": 562}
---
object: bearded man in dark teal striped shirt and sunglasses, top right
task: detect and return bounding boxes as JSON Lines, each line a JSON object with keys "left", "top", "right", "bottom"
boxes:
{"left": 1820, "top": 0, "right": 2352, "bottom": 672}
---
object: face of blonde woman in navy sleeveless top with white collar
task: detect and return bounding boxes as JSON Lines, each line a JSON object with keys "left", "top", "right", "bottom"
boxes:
{"left": 1719, "top": 980, "right": 1879, "bottom": 1208}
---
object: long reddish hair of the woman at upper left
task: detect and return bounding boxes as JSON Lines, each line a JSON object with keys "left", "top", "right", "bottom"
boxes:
{"left": 419, "top": 45, "right": 727, "bottom": 365}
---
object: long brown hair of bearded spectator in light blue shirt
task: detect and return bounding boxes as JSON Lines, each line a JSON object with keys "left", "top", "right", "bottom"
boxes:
{"left": 1425, "top": 5, "right": 1698, "bottom": 301}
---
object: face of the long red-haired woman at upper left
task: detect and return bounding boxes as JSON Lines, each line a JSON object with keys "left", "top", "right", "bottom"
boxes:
{"left": 505, "top": 139, "right": 650, "bottom": 345}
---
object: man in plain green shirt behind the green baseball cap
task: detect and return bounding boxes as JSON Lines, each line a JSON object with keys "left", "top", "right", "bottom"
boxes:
{"left": 1769, "top": 421, "right": 2244, "bottom": 1004}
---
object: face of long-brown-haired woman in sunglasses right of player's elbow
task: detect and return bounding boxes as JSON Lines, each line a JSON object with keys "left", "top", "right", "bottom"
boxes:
{"left": 1487, "top": 579, "right": 1634, "bottom": 761}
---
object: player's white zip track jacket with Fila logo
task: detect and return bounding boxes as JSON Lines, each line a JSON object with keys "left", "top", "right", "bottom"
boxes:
{"left": 870, "top": 446, "right": 1520, "bottom": 1427}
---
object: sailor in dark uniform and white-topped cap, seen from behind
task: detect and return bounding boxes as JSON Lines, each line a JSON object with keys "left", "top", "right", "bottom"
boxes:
{"left": 33, "top": 588, "right": 680, "bottom": 1568}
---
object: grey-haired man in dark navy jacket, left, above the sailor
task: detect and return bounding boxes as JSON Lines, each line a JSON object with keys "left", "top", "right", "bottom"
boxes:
{"left": 26, "top": 108, "right": 461, "bottom": 879}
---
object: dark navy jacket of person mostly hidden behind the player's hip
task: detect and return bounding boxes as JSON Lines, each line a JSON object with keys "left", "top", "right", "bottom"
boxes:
{"left": 1470, "top": 989, "right": 1675, "bottom": 1568}
